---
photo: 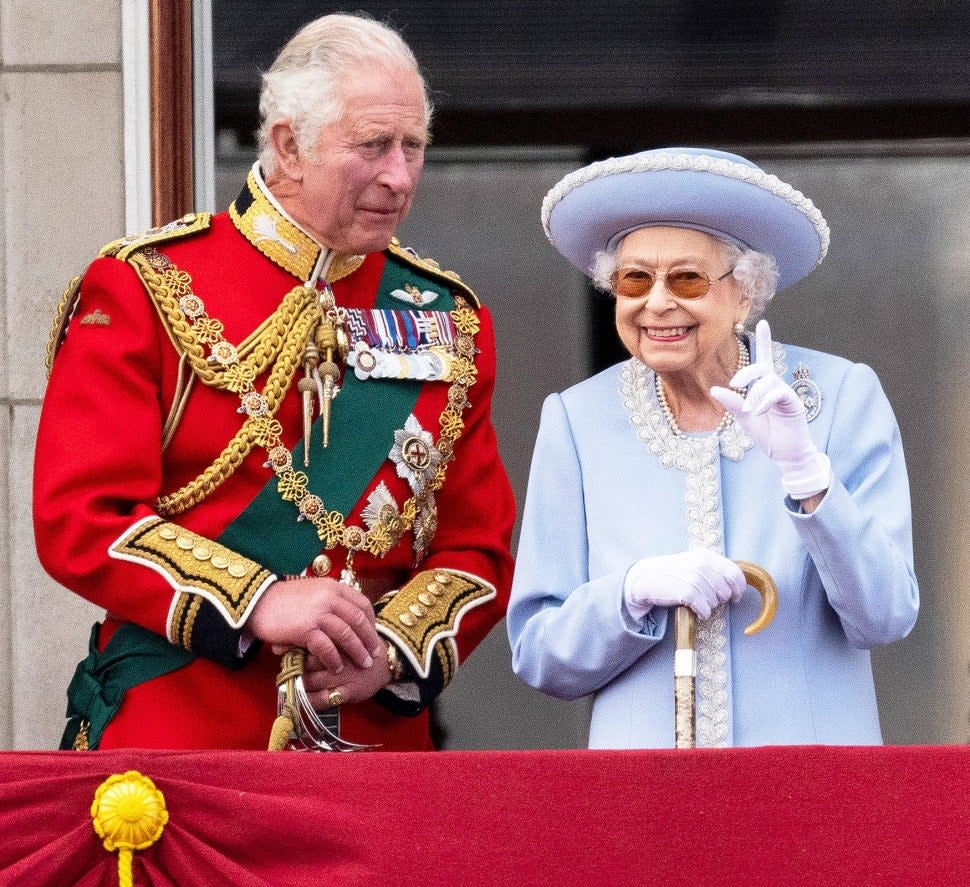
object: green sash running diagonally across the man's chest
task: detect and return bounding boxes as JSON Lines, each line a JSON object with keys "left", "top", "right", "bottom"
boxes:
{"left": 217, "top": 256, "right": 454, "bottom": 575}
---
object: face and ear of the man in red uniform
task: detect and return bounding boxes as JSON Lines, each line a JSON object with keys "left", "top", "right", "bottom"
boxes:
{"left": 267, "top": 67, "right": 427, "bottom": 254}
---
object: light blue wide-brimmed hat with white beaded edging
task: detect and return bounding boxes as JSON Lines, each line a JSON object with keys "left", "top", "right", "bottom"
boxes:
{"left": 542, "top": 148, "right": 829, "bottom": 290}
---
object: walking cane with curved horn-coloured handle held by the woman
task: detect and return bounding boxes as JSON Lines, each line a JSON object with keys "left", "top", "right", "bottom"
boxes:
{"left": 674, "top": 561, "right": 778, "bottom": 748}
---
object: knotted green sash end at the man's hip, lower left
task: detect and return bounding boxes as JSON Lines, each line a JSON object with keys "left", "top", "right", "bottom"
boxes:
{"left": 61, "top": 622, "right": 195, "bottom": 749}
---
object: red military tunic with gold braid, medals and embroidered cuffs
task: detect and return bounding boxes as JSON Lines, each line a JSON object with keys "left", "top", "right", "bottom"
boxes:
{"left": 34, "top": 166, "right": 514, "bottom": 749}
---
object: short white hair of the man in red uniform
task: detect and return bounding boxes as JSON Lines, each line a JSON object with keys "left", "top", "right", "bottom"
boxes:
{"left": 257, "top": 14, "right": 432, "bottom": 175}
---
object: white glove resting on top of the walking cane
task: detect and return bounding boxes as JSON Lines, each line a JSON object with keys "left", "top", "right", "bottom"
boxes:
{"left": 623, "top": 548, "right": 747, "bottom": 619}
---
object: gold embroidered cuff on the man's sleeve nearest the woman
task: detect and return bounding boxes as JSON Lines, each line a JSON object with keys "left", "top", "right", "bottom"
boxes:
{"left": 377, "top": 570, "right": 495, "bottom": 684}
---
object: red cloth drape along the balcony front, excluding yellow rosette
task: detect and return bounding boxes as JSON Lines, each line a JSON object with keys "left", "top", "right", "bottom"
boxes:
{"left": 0, "top": 747, "right": 970, "bottom": 887}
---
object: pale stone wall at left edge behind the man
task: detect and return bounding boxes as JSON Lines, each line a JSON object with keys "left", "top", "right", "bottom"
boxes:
{"left": 0, "top": 0, "right": 125, "bottom": 748}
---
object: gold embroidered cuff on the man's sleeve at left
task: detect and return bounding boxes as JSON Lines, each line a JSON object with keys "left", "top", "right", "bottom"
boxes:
{"left": 111, "top": 518, "right": 272, "bottom": 628}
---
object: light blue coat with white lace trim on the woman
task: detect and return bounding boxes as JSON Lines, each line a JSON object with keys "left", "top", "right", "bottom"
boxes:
{"left": 508, "top": 345, "right": 919, "bottom": 748}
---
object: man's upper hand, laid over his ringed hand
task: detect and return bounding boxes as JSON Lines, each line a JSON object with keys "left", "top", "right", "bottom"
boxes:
{"left": 246, "top": 577, "right": 386, "bottom": 672}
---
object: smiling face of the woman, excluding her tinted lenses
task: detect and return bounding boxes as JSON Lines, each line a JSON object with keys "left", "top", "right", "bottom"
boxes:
{"left": 616, "top": 228, "right": 750, "bottom": 386}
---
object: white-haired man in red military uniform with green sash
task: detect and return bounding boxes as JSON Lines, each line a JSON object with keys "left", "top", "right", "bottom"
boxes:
{"left": 34, "top": 15, "right": 514, "bottom": 749}
